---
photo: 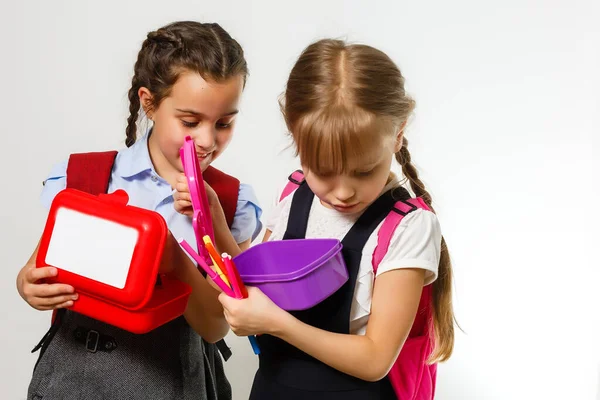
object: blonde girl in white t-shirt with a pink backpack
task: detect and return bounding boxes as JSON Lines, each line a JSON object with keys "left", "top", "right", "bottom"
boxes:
{"left": 178, "top": 40, "right": 454, "bottom": 400}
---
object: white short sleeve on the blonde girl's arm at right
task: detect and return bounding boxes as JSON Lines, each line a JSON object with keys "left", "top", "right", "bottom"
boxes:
{"left": 377, "top": 209, "right": 442, "bottom": 285}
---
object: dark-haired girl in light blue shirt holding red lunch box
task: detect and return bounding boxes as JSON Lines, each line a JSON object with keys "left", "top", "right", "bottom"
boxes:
{"left": 17, "top": 22, "right": 261, "bottom": 400}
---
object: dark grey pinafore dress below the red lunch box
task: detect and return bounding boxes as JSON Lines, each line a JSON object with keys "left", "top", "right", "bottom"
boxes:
{"left": 27, "top": 310, "right": 231, "bottom": 400}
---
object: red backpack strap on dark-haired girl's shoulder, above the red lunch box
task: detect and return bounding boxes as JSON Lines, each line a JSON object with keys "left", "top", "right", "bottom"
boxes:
{"left": 67, "top": 151, "right": 117, "bottom": 196}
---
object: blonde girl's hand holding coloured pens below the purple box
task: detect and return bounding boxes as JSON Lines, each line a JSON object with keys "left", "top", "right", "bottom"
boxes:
{"left": 219, "top": 287, "right": 289, "bottom": 336}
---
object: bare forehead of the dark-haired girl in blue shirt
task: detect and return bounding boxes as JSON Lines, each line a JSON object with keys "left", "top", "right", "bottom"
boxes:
{"left": 168, "top": 72, "right": 244, "bottom": 115}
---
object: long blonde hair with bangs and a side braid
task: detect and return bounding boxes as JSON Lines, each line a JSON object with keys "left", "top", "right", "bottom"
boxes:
{"left": 280, "top": 39, "right": 454, "bottom": 363}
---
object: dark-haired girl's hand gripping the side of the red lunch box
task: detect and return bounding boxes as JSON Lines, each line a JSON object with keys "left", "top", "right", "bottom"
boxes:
{"left": 17, "top": 264, "right": 78, "bottom": 311}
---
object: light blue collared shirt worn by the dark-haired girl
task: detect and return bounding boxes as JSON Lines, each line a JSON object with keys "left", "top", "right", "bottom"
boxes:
{"left": 41, "top": 134, "right": 262, "bottom": 248}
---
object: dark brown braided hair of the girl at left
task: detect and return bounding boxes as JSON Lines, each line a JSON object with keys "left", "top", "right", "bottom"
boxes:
{"left": 125, "top": 21, "right": 248, "bottom": 147}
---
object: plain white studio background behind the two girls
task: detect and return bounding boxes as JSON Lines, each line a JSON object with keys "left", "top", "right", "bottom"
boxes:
{"left": 0, "top": 0, "right": 600, "bottom": 400}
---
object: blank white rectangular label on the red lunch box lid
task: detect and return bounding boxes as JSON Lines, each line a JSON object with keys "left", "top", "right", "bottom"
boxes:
{"left": 46, "top": 207, "right": 139, "bottom": 289}
